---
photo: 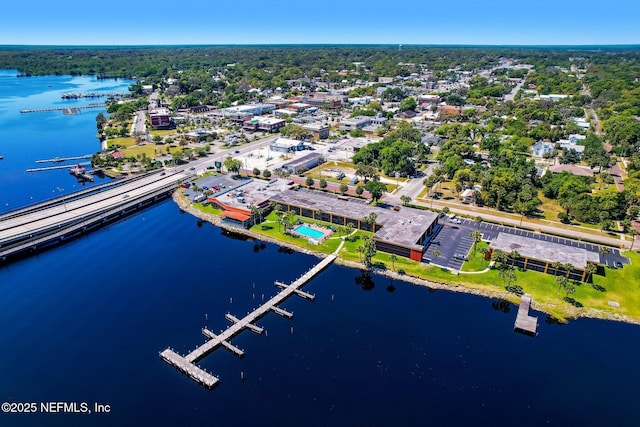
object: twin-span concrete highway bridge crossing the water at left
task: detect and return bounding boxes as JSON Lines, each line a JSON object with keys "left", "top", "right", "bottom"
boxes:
{"left": 0, "top": 170, "right": 193, "bottom": 265}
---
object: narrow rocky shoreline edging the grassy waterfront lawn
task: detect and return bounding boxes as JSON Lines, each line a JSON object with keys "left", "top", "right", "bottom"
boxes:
{"left": 171, "top": 189, "right": 640, "bottom": 325}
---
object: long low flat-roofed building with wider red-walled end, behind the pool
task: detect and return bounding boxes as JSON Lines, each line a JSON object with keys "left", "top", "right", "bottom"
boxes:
{"left": 271, "top": 189, "right": 438, "bottom": 261}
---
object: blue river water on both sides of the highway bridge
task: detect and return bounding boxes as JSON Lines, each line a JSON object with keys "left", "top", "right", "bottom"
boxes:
{"left": 0, "top": 71, "right": 640, "bottom": 426}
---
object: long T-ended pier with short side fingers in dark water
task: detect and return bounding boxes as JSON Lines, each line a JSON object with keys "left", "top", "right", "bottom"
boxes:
{"left": 160, "top": 254, "right": 336, "bottom": 389}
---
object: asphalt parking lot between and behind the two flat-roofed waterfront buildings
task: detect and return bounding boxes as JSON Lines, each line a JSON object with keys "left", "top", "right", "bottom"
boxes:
{"left": 423, "top": 217, "right": 629, "bottom": 270}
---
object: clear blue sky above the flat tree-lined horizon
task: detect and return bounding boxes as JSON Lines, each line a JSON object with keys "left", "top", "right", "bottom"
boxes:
{"left": 0, "top": 0, "right": 640, "bottom": 45}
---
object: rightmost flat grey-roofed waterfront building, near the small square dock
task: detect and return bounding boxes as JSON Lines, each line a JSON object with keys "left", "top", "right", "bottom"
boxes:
{"left": 489, "top": 233, "right": 600, "bottom": 282}
